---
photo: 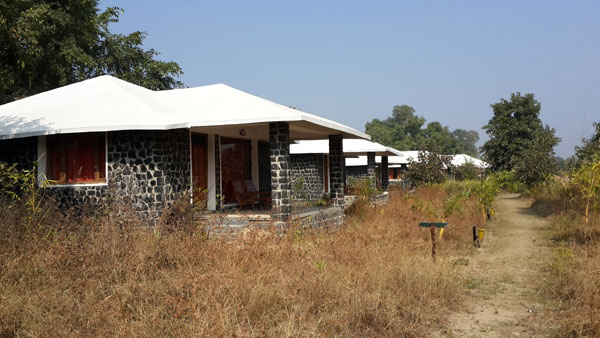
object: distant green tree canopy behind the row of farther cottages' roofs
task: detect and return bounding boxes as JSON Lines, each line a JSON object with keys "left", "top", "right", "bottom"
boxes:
{"left": 365, "top": 105, "right": 479, "bottom": 156}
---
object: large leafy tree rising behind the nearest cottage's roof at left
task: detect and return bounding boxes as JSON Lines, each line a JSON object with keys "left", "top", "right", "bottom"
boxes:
{"left": 0, "top": 0, "right": 183, "bottom": 104}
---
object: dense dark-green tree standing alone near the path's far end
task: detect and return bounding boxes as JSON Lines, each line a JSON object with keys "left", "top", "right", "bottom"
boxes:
{"left": 481, "top": 92, "right": 560, "bottom": 176}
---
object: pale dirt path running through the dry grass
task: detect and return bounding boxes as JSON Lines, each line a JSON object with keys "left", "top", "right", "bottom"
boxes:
{"left": 437, "top": 194, "right": 552, "bottom": 337}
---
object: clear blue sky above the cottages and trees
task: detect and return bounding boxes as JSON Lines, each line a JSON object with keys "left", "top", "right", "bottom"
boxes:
{"left": 100, "top": 0, "right": 600, "bottom": 157}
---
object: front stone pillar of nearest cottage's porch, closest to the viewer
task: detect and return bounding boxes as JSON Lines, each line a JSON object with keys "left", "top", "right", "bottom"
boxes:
{"left": 269, "top": 122, "right": 292, "bottom": 223}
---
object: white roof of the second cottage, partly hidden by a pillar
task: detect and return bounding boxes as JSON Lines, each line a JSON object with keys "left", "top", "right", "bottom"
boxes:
{"left": 290, "top": 139, "right": 399, "bottom": 159}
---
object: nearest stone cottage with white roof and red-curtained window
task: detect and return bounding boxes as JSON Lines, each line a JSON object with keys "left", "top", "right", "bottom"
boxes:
{"left": 0, "top": 75, "right": 370, "bottom": 222}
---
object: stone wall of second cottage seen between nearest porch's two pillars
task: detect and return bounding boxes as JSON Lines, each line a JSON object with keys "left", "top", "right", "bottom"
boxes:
{"left": 290, "top": 154, "right": 325, "bottom": 202}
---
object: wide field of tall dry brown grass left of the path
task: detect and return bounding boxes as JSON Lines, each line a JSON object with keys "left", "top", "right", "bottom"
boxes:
{"left": 0, "top": 187, "right": 478, "bottom": 337}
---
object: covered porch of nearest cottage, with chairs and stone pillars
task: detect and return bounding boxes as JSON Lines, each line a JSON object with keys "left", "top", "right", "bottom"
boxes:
{"left": 189, "top": 121, "right": 357, "bottom": 227}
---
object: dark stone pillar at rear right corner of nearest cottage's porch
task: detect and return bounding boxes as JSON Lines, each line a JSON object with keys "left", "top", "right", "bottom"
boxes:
{"left": 329, "top": 135, "right": 345, "bottom": 208}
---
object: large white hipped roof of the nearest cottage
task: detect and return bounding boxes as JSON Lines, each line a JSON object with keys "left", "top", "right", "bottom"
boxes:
{"left": 0, "top": 75, "right": 370, "bottom": 139}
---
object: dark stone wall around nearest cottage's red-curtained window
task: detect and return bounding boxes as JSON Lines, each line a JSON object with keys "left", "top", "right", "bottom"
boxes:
{"left": 0, "top": 129, "right": 191, "bottom": 218}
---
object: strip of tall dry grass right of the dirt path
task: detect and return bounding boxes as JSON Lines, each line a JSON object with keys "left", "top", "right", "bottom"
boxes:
{"left": 533, "top": 180, "right": 600, "bottom": 337}
